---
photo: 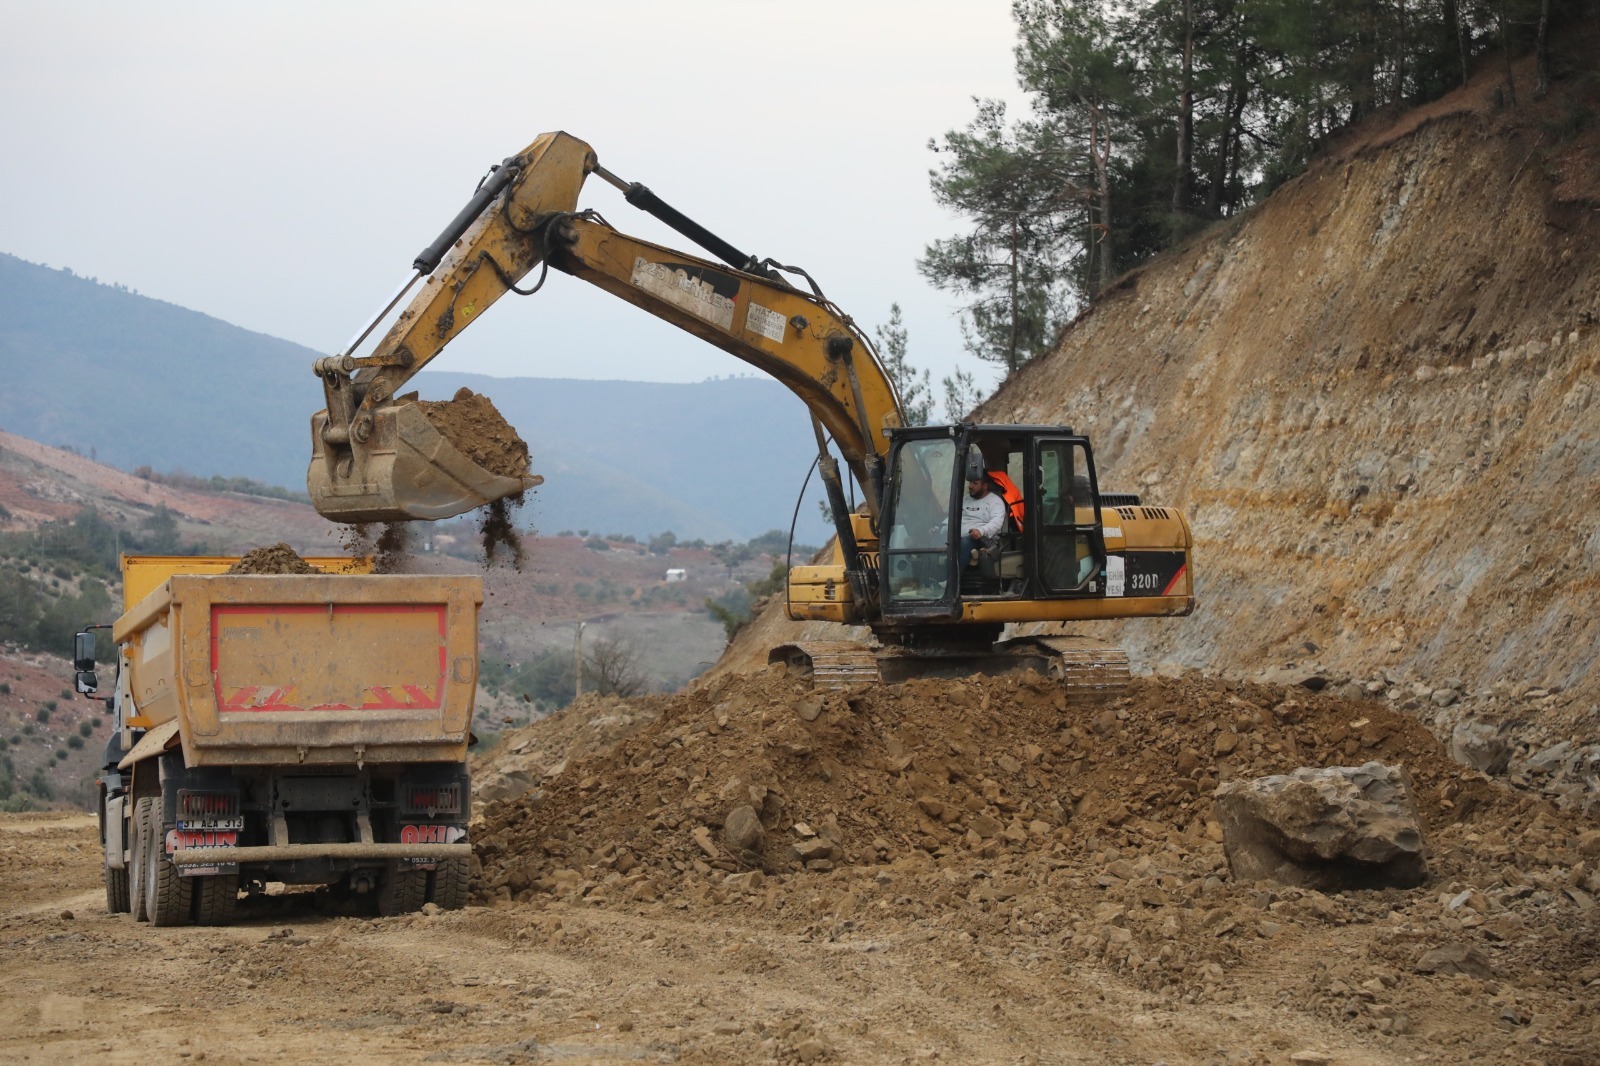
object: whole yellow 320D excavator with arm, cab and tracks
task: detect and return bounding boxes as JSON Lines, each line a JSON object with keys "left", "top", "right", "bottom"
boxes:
{"left": 306, "top": 133, "right": 1194, "bottom": 696}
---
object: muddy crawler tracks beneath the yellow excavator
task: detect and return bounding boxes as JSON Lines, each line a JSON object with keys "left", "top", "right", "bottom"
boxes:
{"left": 766, "top": 637, "right": 1133, "bottom": 706}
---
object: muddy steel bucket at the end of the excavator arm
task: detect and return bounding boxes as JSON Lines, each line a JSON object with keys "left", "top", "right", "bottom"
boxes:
{"left": 306, "top": 403, "right": 544, "bottom": 523}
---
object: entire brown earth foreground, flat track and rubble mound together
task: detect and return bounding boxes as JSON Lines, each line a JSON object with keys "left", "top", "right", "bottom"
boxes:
{"left": 0, "top": 674, "right": 1600, "bottom": 1066}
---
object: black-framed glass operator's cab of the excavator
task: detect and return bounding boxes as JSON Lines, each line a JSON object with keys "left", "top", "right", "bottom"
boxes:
{"left": 878, "top": 426, "right": 1107, "bottom": 619}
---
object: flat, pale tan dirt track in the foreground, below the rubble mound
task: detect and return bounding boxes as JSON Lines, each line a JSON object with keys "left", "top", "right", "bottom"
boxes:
{"left": 0, "top": 815, "right": 1376, "bottom": 1064}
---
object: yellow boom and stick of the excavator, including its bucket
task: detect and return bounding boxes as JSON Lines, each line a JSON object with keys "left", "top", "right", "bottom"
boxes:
{"left": 307, "top": 133, "right": 902, "bottom": 522}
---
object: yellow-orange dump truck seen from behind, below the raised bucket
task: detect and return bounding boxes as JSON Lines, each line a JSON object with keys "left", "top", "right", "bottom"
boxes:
{"left": 74, "top": 555, "right": 483, "bottom": 925}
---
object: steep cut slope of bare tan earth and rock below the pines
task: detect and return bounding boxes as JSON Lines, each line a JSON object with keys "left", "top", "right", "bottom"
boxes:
{"left": 726, "top": 58, "right": 1600, "bottom": 806}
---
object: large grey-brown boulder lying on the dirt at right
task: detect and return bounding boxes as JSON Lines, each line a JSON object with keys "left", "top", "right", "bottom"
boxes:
{"left": 1216, "top": 762, "right": 1427, "bottom": 892}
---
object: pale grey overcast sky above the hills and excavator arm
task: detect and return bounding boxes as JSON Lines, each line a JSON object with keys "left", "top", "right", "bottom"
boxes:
{"left": 0, "top": 0, "right": 1021, "bottom": 398}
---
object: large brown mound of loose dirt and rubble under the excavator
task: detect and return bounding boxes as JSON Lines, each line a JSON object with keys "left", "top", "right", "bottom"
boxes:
{"left": 474, "top": 674, "right": 1600, "bottom": 1061}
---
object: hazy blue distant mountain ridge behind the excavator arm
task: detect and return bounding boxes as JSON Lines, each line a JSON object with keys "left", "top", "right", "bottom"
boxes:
{"left": 0, "top": 254, "right": 822, "bottom": 541}
